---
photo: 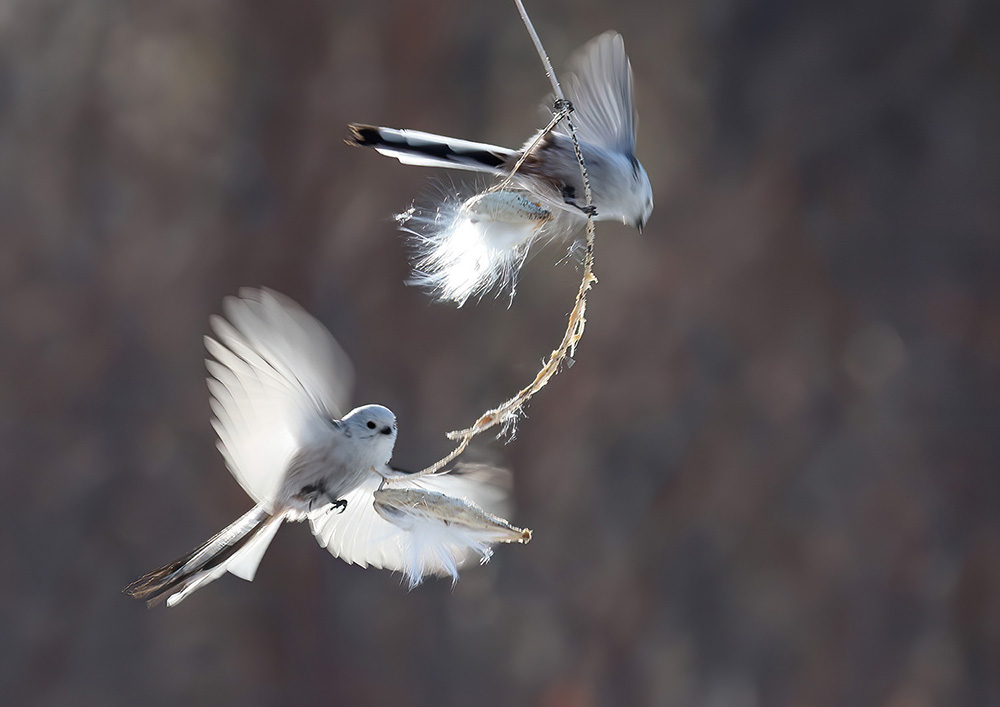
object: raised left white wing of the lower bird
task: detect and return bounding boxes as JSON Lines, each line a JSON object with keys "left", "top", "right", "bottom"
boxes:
{"left": 205, "top": 289, "right": 353, "bottom": 506}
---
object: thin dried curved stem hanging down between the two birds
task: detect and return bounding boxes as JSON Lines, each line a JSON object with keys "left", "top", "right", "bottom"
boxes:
{"left": 385, "top": 0, "right": 597, "bottom": 484}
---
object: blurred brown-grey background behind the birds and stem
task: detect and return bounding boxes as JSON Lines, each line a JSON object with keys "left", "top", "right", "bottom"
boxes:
{"left": 0, "top": 0, "right": 1000, "bottom": 707}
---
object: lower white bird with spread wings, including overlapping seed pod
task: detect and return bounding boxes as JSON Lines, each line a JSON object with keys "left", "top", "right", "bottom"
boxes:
{"left": 126, "top": 289, "right": 530, "bottom": 606}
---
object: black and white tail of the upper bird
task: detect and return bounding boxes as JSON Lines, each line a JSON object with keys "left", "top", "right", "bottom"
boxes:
{"left": 346, "top": 123, "right": 517, "bottom": 174}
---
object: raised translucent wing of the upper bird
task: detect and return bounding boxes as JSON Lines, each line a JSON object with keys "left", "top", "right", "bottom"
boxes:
{"left": 561, "top": 32, "right": 636, "bottom": 155}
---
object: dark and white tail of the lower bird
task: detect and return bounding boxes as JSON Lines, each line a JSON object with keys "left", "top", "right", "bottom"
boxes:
{"left": 125, "top": 506, "right": 285, "bottom": 607}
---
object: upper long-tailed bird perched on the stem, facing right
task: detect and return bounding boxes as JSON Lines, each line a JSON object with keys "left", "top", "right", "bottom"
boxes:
{"left": 349, "top": 32, "right": 653, "bottom": 231}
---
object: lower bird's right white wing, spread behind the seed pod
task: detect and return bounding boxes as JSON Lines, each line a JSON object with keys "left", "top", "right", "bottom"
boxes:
{"left": 309, "top": 466, "right": 509, "bottom": 586}
